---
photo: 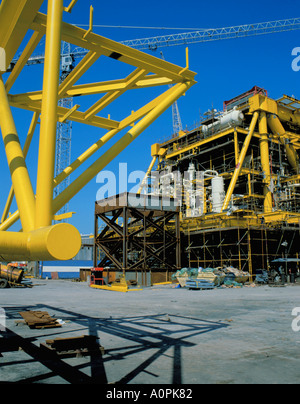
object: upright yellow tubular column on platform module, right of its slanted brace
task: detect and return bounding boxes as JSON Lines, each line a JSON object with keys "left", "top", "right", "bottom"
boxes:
{"left": 259, "top": 111, "right": 273, "bottom": 213}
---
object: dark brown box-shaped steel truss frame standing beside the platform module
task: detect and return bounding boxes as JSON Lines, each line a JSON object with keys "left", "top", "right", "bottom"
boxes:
{"left": 94, "top": 194, "right": 181, "bottom": 284}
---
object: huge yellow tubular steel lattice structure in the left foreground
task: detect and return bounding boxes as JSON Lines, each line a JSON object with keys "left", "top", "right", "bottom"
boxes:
{"left": 0, "top": 0, "right": 195, "bottom": 261}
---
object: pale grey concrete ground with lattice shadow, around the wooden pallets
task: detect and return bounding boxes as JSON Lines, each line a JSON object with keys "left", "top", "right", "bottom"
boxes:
{"left": 0, "top": 280, "right": 300, "bottom": 385}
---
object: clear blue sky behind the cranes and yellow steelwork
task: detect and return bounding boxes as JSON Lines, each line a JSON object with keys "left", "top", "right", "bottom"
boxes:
{"left": 0, "top": 0, "right": 300, "bottom": 234}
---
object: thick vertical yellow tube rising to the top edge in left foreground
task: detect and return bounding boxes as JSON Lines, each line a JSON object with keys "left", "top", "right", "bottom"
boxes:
{"left": 35, "top": 0, "right": 63, "bottom": 229}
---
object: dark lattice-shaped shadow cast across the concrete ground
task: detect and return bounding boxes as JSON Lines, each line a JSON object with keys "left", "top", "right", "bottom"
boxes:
{"left": 0, "top": 305, "right": 228, "bottom": 384}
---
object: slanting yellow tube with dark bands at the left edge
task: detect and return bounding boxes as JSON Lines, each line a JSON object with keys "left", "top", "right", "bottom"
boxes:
{"left": 0, "top": 76, "right": 35, "bottom": 231}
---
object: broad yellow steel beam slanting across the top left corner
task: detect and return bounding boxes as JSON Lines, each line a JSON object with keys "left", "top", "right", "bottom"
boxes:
{"left": 0, "top": 0, "right": 44, "bottom": 68}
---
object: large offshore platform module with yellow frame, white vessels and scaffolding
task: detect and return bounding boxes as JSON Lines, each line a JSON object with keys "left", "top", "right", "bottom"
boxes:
{"left": 141, "top": 87, "right": 300, "bottom": 273}
